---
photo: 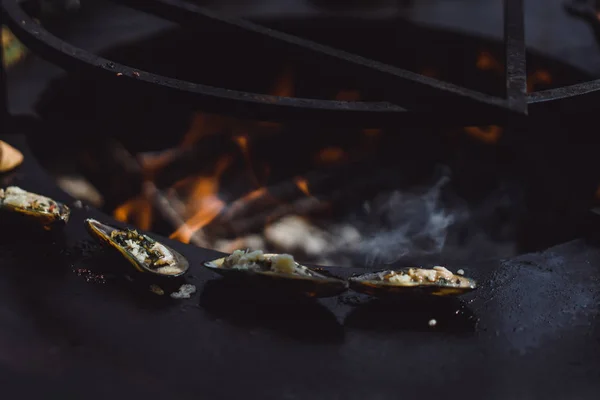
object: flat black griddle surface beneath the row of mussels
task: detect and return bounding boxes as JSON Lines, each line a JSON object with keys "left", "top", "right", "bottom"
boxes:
{"left": 0, "top": 136, "right": 600, "bottom": 399}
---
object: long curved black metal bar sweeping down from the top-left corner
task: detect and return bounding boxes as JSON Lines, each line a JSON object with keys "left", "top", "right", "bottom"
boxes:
{"left": 1, "top": 0, "right": 422, "bottom": 126}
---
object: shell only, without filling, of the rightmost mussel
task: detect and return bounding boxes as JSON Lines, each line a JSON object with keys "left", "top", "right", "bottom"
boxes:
{"left": 348, "top": 268, "right": 477, "bottom": 297}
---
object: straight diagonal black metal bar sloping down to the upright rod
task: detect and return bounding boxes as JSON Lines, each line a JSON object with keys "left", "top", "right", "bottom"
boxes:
{"left": 112, "top": 0, "right": 526, "bottom": 118}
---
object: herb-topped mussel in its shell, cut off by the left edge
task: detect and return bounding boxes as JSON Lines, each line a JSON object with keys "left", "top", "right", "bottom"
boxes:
{"left": 0, "top": 186, "right": 71, "bottom": 227}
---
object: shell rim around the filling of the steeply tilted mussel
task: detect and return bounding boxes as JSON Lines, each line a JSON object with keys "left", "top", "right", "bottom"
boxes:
{"left": 85, "top": 218, "right": 189, "bottom": 278}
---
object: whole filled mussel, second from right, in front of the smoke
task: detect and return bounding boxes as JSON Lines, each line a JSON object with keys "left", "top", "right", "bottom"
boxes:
{"left": 204, "top": 250, "right": 348, "bottom": 297}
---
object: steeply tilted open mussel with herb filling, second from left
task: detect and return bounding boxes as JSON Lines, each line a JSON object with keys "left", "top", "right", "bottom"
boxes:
{"left": 85, "top": 218, "right": 189, "bottom": 278}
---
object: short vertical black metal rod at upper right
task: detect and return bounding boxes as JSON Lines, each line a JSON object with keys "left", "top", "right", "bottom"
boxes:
{"left": 504, "top": 0, "right": 527, "bottom": 114}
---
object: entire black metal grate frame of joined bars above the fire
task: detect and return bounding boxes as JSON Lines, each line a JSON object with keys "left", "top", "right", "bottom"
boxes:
{"left": 0, "top": 0, "right": 600, "bottom": 126}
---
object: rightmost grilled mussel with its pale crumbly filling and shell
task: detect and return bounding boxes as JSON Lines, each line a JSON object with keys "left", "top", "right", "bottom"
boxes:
{"left": 348, "top": 267, "right": 477, "bottom": 297}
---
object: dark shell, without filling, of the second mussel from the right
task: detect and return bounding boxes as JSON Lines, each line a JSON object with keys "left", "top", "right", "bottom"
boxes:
{"left": 204, "top": 254, "right": 348, "bottom": 297}
